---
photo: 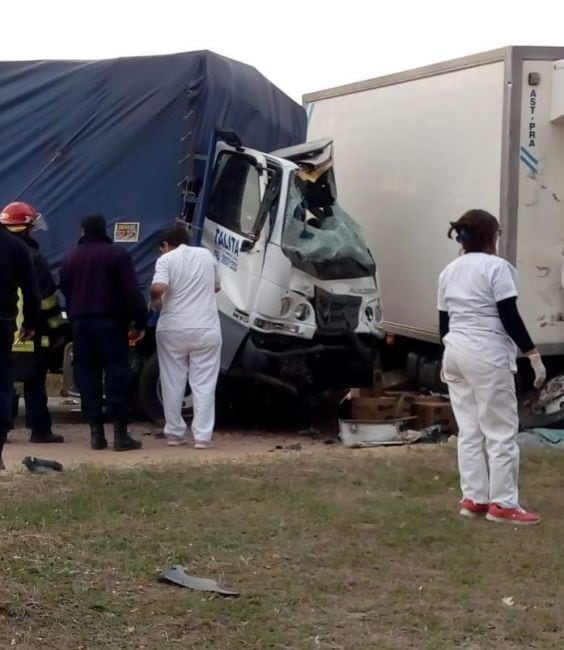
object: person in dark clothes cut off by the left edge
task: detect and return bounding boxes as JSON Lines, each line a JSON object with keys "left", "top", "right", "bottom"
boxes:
{"left": 0, "top": 218, "right": 39, "bottom": 469}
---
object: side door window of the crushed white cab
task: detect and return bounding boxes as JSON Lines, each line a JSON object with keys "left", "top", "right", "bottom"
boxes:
{"left": 208, "top": 152, "right": 261, "bottom": 238}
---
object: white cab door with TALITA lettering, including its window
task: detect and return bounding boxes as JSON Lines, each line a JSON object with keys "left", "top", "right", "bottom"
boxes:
{"left": 202, "top": 147, "right": 269, "bottom": 321}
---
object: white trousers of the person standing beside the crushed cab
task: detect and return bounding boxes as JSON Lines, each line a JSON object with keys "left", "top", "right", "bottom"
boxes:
{"left": 157, "top": 328, "right": 221, "bottom": 441}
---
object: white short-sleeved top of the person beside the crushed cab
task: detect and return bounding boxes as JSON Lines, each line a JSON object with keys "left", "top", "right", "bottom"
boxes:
{"left": 153, "top": 244, "right": 219, "bottom": 331}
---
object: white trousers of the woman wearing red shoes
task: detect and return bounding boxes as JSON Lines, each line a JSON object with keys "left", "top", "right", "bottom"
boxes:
{"left": 443, "top": 344, "right": 519, "bottom": 508}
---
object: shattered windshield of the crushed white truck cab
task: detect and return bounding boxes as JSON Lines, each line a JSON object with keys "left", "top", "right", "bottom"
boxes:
{"left": 282, "top": 170, "right": 375, "bottom": 280}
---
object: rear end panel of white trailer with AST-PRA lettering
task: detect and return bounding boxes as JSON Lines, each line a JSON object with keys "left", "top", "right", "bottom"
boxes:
{"left": 516, "top": 60, "right": 564, "bottom": 354}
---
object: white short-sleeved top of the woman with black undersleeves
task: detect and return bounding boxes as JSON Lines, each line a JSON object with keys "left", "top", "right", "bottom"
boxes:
{"left": 438, "top": 253, "right": 518, "bottom": 372}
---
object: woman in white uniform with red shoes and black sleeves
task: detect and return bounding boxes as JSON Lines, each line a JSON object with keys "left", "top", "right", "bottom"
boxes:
{"left": 438, "top": 210, "right": 546, "bottom": 525}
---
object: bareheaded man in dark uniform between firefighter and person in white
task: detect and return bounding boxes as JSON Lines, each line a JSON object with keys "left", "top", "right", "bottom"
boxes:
{"left": 61, "top": 215, "right": 147, "bottom": 451}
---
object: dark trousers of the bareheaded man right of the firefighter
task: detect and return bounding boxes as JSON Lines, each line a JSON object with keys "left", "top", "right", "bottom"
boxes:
{"left": 72, "top": 318, "right": 131, "bottom": 424}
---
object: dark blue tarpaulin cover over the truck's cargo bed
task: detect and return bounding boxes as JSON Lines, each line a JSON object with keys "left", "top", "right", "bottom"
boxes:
{"left": 0, "top": 51, "right": 306, "bottom": 287}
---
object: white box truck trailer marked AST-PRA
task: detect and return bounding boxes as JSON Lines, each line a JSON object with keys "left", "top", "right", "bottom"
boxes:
{"left": 304, "top": 47, "right": 564, "bottom": 420}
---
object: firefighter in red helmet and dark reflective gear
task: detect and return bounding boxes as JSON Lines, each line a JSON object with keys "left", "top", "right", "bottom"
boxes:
{"left": 0, "top": 201, "right": 65, "bottom": 443}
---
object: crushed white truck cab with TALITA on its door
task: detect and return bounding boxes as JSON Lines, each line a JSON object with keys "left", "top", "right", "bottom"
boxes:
{"left": 196, "top": 140, "right": 383, "bottom": 393}
